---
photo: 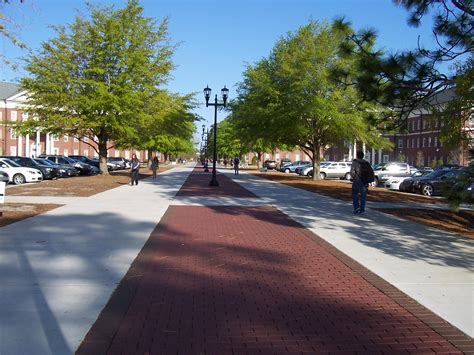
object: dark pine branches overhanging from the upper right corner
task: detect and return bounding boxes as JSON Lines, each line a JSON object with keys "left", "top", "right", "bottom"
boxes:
{"left": 334, "top": 0, "right": 474, "bottom": 144}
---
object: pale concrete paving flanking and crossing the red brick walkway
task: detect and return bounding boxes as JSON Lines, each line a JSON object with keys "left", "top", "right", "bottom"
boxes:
{"left": 0, "top": 167, "right": 474, "bottom": 355}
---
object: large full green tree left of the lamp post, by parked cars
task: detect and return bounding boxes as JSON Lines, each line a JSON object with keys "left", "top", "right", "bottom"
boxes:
{"left": 21, "top": 0, "right": 178, "bottom": 173}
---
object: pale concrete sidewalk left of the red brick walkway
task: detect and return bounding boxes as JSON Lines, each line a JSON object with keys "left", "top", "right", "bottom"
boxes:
{"left": 0, "top": 167, "right": 191, "bottom": 355}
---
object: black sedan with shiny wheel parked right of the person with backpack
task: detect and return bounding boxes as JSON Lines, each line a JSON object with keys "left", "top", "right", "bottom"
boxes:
{"left": 400, "top": 169, "right": 463, "bottom": 196}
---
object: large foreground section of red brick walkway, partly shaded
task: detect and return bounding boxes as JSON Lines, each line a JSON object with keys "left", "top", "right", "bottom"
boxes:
{"left": 78, "top": 174, "right": 474, "bottom": 354}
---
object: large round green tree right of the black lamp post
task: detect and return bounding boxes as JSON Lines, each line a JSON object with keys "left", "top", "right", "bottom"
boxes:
{"left": 232, "top": 21, "right": 383, "bottom": 179}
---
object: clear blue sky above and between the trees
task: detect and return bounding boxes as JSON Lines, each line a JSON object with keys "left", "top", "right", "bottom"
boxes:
{"left": 0, "top": 0, "right": 432, "bottom": 132}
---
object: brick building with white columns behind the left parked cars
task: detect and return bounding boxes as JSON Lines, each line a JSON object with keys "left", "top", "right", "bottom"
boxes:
{"left": 0, "top": 82, "right": 152, "bottom": 160}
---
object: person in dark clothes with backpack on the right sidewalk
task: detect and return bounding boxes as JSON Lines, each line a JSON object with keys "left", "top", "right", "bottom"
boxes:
{"left": 351, "top": 150, "right": 374, "bottom": 215}
